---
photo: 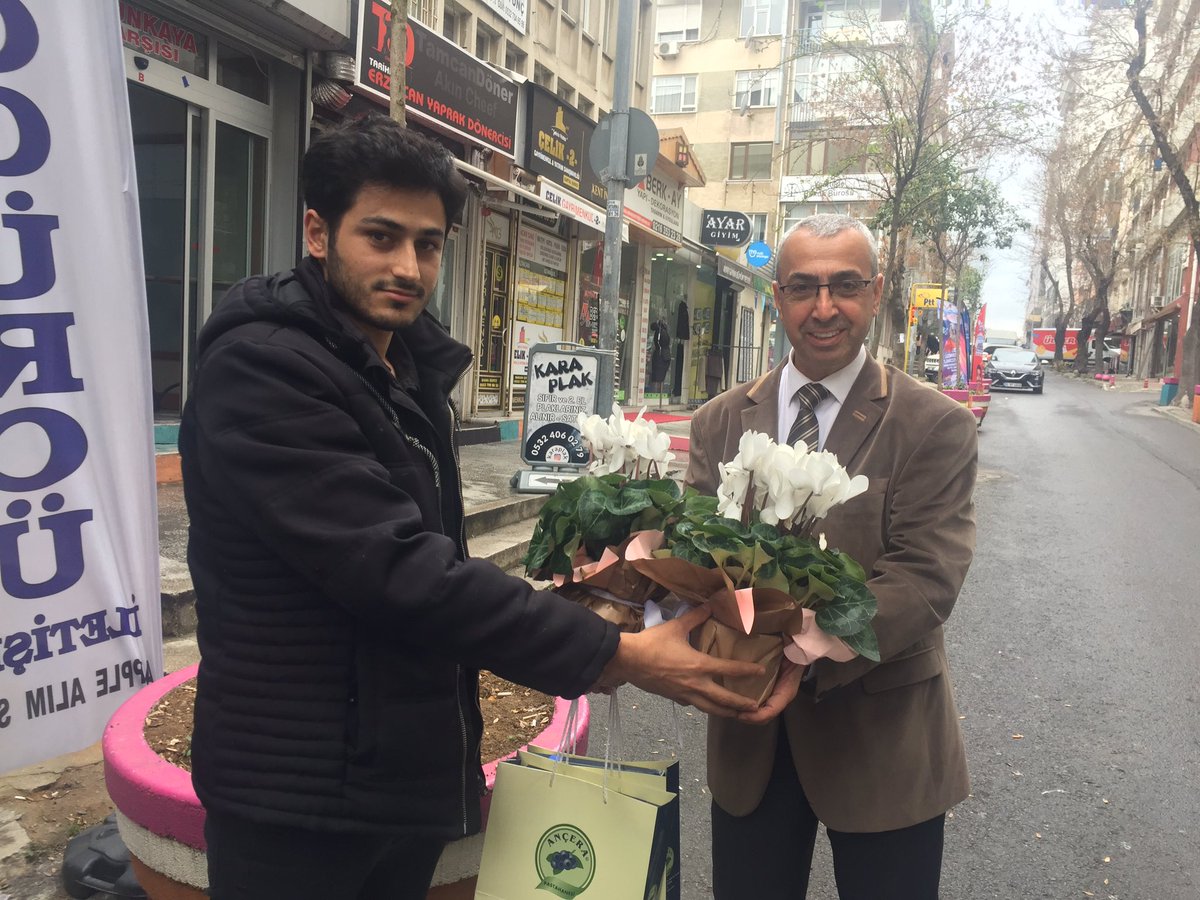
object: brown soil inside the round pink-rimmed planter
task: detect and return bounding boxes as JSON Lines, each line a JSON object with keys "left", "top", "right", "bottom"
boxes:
{"left": 145, "top": 672, "right": 554, "bottom": 772}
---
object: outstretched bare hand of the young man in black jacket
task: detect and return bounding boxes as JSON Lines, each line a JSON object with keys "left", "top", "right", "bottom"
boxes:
{"left": 593, "top": 605, "right": 763, "bottom": 721}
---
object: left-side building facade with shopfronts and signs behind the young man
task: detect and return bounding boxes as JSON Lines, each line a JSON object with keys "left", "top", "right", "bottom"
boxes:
{"left": 120, "top": 0, "right": 729, "bottom": 427}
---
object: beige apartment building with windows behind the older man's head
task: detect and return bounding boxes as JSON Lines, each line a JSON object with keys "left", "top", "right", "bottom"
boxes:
{"left": 650, "top": 0, "right": 908, "bottom": 374}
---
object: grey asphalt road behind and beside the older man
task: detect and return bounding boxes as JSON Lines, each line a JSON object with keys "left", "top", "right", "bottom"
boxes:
{"left": 593, "top": 376, "right": 1200, "bottom": 900}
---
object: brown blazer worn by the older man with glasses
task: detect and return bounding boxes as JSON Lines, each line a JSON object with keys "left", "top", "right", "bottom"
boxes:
{"left": 686, "top": 356, "right": 977, "bottom": 832}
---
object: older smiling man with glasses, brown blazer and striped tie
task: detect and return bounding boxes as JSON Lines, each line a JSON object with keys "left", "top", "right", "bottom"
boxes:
{"left": 688, "top": 216, "right": 977, "bottom": 900}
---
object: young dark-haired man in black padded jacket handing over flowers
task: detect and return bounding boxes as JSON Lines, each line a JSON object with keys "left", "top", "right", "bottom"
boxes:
{"left": 180, "top": 116, "right": 780, "bottom": 900}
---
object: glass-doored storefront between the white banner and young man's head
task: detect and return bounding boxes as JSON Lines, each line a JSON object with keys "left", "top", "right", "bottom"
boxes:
{"left": 120, "top": 0, "right": 324, "bottom": 419}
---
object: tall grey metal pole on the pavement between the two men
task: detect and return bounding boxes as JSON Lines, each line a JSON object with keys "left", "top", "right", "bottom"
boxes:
{"left": 596, "top": 0, "right": 637, "bottom": 415}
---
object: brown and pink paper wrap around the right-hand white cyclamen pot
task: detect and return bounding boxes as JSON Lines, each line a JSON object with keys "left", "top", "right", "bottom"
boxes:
{"left": 626, "top": 532, "right": 858, "bottom": 703}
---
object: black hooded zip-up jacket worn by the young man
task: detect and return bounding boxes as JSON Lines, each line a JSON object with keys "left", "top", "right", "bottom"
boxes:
{"left": 180, "top": 259, "right": 618, "bottom": 839}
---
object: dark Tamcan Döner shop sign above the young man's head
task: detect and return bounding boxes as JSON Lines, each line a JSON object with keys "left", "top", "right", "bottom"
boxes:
{"left": 355, "top": 0, "right": 517, "bottom": 157}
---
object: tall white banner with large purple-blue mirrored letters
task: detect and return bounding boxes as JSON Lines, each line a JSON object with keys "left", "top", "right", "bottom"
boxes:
{"left": 0, "top": 0, "right": 162, "bottom": 772}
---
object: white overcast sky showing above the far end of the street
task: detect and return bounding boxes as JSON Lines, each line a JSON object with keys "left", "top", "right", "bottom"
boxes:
{"left": 983, "top": 0, "right": 1084, "bottom": 334}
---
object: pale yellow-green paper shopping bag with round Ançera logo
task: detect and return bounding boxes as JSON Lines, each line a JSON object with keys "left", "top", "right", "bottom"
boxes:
{"left": 475, "top": 762, "right": 679, "bottom": 900}
